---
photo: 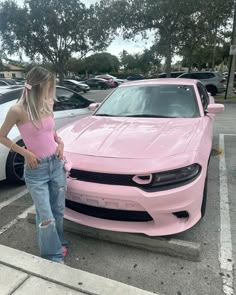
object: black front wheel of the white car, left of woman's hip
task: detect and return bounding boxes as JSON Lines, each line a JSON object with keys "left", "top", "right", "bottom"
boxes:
{"left": 6, "top": 140, "right": 25, "bottom": 184}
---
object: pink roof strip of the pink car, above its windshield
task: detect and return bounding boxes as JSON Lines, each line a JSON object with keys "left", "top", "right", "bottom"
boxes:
{"left": 119, "top": 78, "right": 199, "bottom": 87}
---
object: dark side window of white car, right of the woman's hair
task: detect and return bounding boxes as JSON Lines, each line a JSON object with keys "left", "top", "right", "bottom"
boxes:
{"left": 54, "top": 88, "right": 89, "bottom": 111}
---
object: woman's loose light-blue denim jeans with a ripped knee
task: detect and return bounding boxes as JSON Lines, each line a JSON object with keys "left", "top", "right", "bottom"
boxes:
{"left": 24, "top": 155, "right": 66, "bottom": 262}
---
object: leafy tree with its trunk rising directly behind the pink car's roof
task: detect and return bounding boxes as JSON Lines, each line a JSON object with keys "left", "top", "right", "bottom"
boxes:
{"left": 98, "top": 0, "right": 195, "bottom": 75}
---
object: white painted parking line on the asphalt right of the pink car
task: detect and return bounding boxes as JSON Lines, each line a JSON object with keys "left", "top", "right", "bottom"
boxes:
{"left": 219, "top": 134, "right": 235, "bottom": 295}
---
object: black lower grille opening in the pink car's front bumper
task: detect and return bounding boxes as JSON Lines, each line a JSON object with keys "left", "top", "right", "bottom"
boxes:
{"left": 66, "top": 200, "right": 153, "bottom": 222}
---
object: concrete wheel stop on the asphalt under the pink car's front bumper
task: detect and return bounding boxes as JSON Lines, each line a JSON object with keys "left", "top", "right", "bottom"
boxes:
{"left": 27, "top": 211, "right": 200, "bottom": 262}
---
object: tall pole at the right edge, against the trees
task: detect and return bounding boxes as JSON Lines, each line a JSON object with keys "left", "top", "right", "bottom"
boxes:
{"left": 225, "top": 0, "right": 236, "bottom": 99}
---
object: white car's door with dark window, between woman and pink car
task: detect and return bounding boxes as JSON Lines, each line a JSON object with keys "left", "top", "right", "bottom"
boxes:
{"left": 54, "top": 87, "right": 91, "bottom": 129}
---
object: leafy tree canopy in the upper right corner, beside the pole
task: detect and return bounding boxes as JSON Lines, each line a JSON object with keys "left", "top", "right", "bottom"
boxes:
{"left": 178, "top": 0, "right": 233, "bottom": 70}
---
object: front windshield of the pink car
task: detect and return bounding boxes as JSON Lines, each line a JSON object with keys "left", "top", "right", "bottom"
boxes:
{"left": 95, "top": 85, "right": 199, "bottom": 118}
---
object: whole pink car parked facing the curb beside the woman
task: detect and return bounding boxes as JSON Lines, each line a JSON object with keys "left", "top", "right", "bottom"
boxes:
{"left": 60, "top": 79, "right": 224, "bottom": 236}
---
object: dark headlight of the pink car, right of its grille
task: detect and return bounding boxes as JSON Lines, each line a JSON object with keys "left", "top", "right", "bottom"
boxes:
{"left": 151, "top": 164, "right": 201, "bottom": 187}
